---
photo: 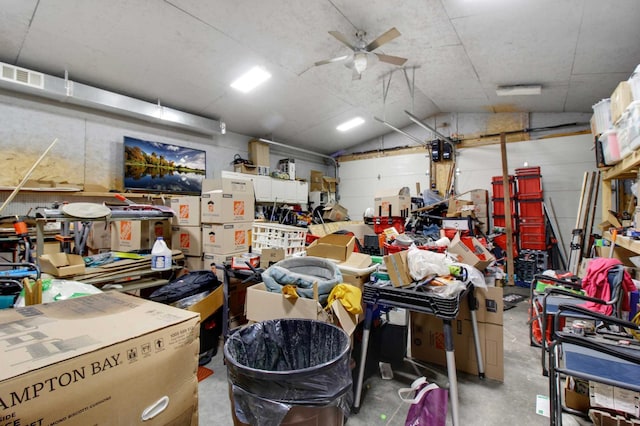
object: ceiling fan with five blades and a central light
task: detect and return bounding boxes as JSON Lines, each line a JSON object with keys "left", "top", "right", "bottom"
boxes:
{"left": 315, "top": 27, "right": 407, "bottom": 80}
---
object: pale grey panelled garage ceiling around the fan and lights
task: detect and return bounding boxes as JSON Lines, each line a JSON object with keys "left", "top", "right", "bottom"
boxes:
{"left": 0, "top": 0, "right": 640, "bottom": 154}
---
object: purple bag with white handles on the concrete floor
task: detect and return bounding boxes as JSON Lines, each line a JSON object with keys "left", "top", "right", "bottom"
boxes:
{"left": 398, "top": 377, "right": 449, "bottom": 426}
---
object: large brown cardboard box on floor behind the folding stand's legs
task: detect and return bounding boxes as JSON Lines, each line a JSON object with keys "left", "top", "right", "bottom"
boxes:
{"left": 411, "top": 312, "right": 504, "bottom": 382}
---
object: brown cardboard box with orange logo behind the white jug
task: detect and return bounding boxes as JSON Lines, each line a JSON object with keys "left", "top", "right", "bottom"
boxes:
{"left": 111, "top": 219, "right": 171, "bottom": 251}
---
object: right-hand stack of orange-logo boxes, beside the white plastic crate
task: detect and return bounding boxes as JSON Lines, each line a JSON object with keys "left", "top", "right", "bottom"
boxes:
{"left": 200, "top": 178, "right": 255, "bottom": 279}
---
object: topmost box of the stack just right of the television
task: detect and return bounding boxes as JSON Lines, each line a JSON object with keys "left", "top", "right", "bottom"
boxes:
{"left": 200, "top": 178, "right": 255, "bottom": 223}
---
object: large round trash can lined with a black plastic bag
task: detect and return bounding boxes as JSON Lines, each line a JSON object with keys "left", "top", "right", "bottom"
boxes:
{"left": 224, "top": 319, "right": 353, "bottom": 426}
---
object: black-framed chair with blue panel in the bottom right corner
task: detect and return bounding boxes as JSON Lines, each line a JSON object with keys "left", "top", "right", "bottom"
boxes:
{"left": 548, "top": 304, "right": 640, "bottom": 425}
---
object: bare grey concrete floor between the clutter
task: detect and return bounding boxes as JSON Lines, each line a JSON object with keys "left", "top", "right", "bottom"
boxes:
{"left": 199, "top": 288, "right": 591, "bottom": 426}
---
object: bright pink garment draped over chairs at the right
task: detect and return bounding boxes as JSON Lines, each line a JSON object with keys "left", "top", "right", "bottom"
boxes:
{"left": 582, "top": 257, "right": 636, "bottom": 315}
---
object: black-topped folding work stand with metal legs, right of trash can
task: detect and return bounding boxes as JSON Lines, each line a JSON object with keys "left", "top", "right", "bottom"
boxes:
{"left": 353, "top": 282, "right": 484, "bottom": 426}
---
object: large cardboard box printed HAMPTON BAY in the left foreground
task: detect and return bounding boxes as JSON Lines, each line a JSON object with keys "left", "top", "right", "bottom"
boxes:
{"left": 0, "top": 292, "right": 200, "bottom": 426}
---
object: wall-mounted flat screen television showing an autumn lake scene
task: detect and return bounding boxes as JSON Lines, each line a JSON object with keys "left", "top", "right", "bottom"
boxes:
{"left": 124, "top": 136, "right": 206, "bottom": 195}
